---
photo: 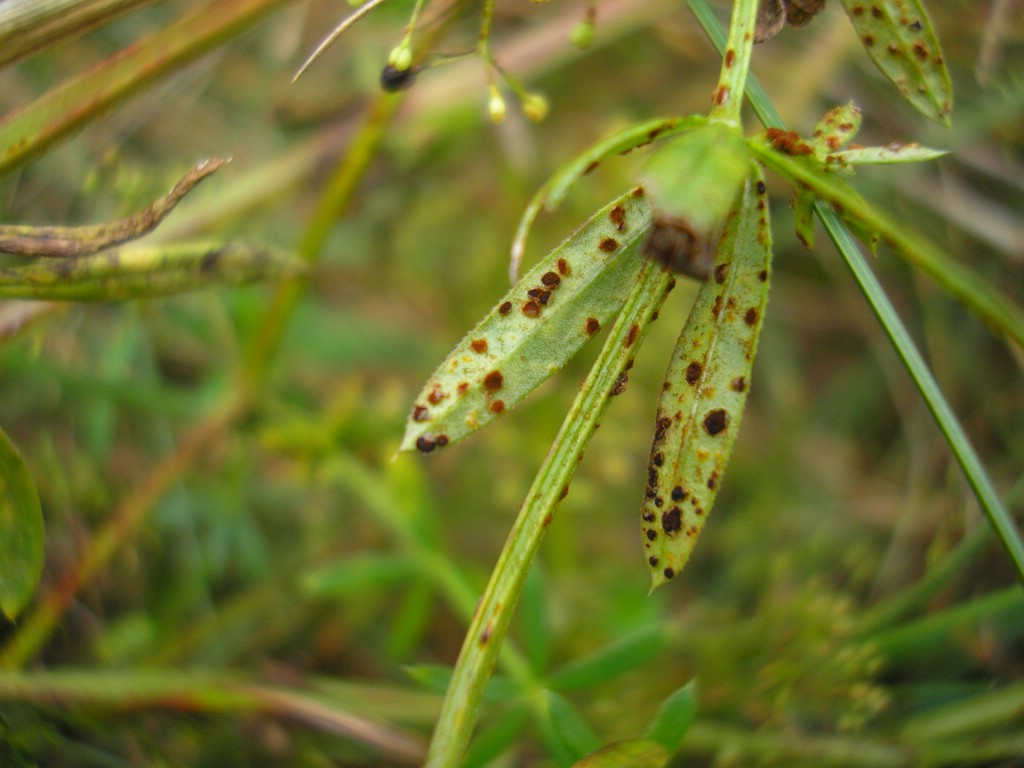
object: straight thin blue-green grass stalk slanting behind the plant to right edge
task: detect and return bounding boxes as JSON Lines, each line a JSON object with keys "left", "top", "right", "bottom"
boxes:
{"left": 688, "top": 0, "right": 1024, "bottom": 583}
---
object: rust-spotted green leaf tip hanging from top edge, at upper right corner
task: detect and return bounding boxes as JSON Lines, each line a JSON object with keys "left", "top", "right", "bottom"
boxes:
{"left": 843, "top": 0, "right": 953, "bottom": 125}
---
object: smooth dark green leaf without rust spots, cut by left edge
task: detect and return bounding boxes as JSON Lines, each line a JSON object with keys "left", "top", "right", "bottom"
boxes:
{"left": 0, "top": 429, "right": 44, "bottom": 620}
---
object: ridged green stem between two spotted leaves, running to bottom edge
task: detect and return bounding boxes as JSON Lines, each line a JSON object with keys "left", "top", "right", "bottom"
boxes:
{"left": 427, "top": 261, "right": 674, "bottom": 768}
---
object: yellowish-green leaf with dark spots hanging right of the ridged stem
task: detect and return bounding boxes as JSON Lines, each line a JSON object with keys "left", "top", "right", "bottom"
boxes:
{"left": 641, "top": 172, "right": 771, "bottom": 589}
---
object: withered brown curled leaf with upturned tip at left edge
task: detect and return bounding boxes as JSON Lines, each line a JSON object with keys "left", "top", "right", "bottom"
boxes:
{"left": 0, "top": 158, "right": 229, "bottom": 258}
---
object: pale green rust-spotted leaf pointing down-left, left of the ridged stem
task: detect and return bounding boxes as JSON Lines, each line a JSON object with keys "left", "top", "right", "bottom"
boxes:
{"left": 400, "top": 189, "right": 650, "bottom": 453}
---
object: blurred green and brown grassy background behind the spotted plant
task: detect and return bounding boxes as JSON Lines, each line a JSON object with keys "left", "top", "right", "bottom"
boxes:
{"left": 0, "top": 0, "right": 1024, "bottom": 766}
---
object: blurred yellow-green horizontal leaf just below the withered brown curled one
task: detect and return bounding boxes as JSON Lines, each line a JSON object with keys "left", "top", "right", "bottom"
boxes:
{"left": 0, "top": 243, "right": 304, "bottom": 301}
